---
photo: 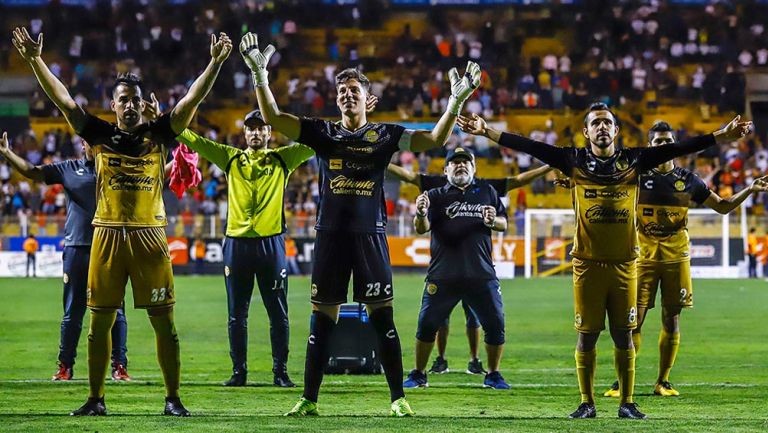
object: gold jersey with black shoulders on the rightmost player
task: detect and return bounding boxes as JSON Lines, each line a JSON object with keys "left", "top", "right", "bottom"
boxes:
{"left": 637, "top": 167, "right": 711, "bottom": 263}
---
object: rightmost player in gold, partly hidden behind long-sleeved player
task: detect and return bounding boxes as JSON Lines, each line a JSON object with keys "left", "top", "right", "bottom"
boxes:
{"left": 604, "top": 122, "right": 768, "bottom": 397}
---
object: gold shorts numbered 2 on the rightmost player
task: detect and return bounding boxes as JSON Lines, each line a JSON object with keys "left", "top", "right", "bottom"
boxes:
{"left": 637, "top": 261, "right": 693, "bottom": 309}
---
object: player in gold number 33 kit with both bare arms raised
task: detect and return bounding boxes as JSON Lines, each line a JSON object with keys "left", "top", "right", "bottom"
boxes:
{"left": 13, "top": 28, "right": 232, "bottom": 416}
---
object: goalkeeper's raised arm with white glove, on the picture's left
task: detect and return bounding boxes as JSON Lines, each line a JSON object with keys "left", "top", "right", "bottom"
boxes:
{"left": 240, "top": 32, "right": 301, "bottom": 140}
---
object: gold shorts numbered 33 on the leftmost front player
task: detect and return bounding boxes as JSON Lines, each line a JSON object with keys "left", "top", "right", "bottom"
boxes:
{"left": 88, "top": 227, "right": 176, "bottom": 308}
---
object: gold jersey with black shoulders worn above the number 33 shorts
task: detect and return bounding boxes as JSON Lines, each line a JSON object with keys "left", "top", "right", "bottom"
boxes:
{"left": 78, "top": 110, "right": 176, "bottom": 227}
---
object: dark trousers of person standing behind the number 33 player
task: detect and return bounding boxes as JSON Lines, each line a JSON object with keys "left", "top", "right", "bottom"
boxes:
{"left": 59, "top": 246, "right": 128, "bottom": 366}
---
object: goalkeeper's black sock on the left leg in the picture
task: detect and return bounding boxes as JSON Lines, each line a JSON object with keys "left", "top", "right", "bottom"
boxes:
{"left": 304, "top": 311, "right": 336, "bottom": 403}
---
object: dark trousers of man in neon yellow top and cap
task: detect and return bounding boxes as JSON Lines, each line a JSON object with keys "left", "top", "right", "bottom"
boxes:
{"left": 224, "top": 235, "right": 289, "bottom": 372}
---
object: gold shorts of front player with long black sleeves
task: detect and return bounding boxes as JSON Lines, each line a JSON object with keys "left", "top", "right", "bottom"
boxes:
{"left": 573, "top": 257, "right": 637, "bottom": 333}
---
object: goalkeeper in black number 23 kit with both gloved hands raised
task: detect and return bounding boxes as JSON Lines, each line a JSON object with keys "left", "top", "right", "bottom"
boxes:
{"left": 240, "top": 33, "right": 480, "bottom": 416}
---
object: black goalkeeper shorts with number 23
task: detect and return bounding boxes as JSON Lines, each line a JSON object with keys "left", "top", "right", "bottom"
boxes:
{"left": 311, "top": 230, "right": 393, "bottom": 305}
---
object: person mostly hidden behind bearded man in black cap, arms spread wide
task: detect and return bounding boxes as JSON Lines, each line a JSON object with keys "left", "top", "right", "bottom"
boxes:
{"left": 387, "top": 160, "right": 551, "bottom": 374}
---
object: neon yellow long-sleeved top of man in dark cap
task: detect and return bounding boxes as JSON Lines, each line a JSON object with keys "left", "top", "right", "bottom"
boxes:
{"left": 176, "top": 129, "right": 315, "bottom": 238}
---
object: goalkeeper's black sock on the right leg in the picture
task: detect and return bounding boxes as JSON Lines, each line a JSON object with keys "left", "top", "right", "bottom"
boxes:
{"left": 371, "top": 307, "right": 405, "bottom": 401}
